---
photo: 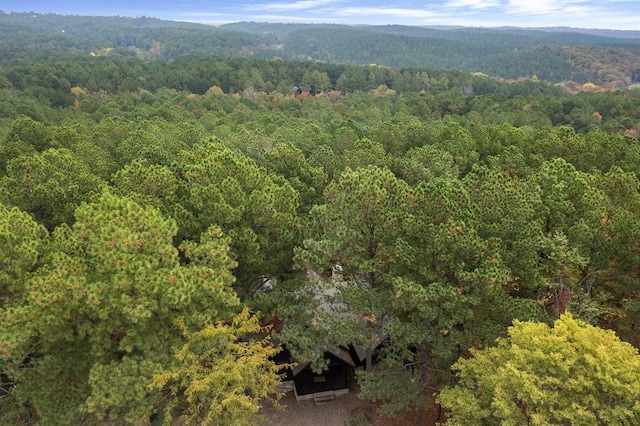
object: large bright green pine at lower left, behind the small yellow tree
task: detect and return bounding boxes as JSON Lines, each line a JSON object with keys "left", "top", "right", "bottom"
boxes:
{"left": 0, "top": 192, "right": 273, "bottom": 424}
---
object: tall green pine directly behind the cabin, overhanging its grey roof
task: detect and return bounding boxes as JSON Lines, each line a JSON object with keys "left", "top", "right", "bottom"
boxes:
{"left": 272, "top": 166, "right": 408, "bottom": 370}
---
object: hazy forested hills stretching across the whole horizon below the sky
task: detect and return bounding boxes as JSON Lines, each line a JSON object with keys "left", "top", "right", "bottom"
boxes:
{"left": 0, "top": 12, "right": 640, "bottom": 88}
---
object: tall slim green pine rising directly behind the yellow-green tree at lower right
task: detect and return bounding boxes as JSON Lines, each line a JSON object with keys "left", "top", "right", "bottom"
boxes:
{"left": 530, "top": 158, "right": 611, "bottom": 319}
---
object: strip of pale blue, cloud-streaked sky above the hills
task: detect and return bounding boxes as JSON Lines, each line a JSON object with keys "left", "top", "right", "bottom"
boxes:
{"left": 5, "top": 0, "right": 640, "bottom": 30}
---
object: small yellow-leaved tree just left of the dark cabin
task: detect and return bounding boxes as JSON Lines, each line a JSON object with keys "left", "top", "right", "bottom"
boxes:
{"left": 151, "top": 308, "right": 280, "bottom": 425}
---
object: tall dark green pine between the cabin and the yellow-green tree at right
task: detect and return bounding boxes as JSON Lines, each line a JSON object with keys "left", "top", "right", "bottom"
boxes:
{"left": 361, "top": 178, "right": 539, "bottom": 424}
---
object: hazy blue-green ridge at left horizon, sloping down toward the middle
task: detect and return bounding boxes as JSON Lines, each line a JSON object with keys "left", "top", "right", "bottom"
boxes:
{"left": 0, "top": 12, "right": 262, "bottom": 61}
